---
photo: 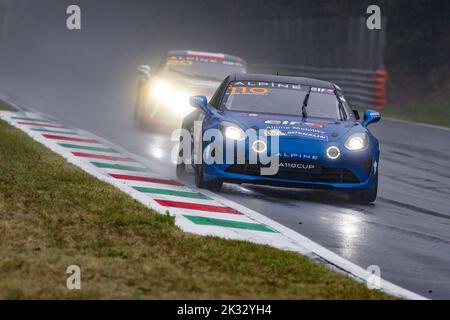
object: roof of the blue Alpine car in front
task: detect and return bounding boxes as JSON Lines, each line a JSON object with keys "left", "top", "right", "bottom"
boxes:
{"left": 230, "top": 73, "right": 334, "bottom": 89}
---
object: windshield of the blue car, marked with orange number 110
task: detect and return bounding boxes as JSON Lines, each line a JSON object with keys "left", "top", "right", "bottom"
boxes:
{"left": 222, "top": 81, "right": 341, "bottom": 120}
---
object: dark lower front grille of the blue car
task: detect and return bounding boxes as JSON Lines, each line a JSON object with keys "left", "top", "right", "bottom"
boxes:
{"left": 226, "top": 163, "right": 360, "bottom": 183}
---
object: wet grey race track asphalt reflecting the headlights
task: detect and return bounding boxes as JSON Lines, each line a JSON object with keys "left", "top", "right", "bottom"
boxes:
{"left": 0, "top": 71, "right": 450, "bottom": 299}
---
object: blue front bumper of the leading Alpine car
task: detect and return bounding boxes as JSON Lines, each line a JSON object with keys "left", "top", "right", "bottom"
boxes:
{"left": 204, "top": 140, "right": 379, "bottom": 189}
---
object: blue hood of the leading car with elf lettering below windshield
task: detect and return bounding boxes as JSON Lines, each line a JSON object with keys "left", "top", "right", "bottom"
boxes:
{"left": 223, "top": 111, "right": 360, "bottom": 141}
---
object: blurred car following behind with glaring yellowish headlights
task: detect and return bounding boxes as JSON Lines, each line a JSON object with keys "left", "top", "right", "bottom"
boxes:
{"left": 134, "top": 50, "right": 246, "bottom": 128}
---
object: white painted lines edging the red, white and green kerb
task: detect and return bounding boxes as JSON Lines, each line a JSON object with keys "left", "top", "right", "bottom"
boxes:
{"left": 0, "top": 95, "right": 426, "bottom": 300}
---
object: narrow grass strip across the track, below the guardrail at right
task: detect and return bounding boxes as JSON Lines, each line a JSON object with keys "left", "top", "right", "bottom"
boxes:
{"left": 381, "top": 100, "right": 450, "bottom": 127}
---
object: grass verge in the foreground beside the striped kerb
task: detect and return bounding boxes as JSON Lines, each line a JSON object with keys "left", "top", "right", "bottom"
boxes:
{"left": 0, "top": 117, "right": 391, "bottom": 299}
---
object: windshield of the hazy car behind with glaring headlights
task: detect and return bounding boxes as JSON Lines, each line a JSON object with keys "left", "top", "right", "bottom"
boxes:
{"left": 162, "top": 56, "right": 245, "bottom": 81}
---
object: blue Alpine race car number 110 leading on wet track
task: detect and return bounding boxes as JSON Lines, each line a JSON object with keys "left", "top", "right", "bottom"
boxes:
{"left": 177, "top": 74, "right": 380, "bottom": 203}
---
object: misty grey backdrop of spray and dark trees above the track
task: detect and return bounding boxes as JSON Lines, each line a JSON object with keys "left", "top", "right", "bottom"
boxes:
{"left": 0, "top": 0, "right": 450, "bottom": 107}
